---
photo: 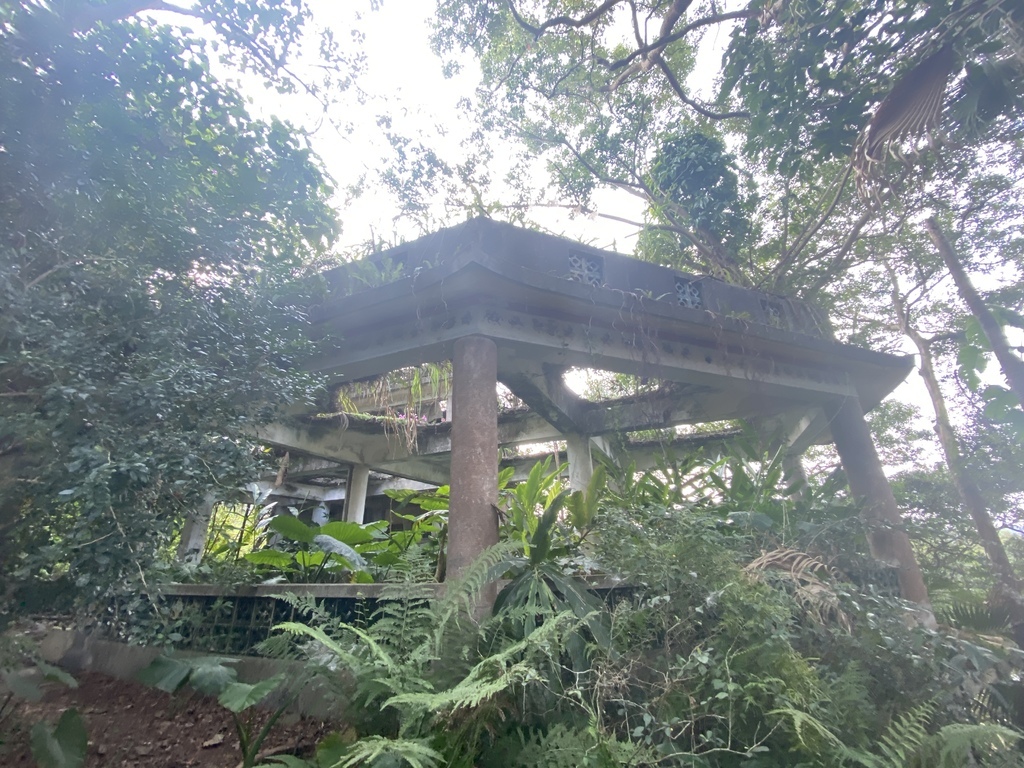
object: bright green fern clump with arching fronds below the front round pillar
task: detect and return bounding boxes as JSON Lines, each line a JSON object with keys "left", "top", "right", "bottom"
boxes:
{"left": 278, "top": 545, "right": 580, "bottom": 768}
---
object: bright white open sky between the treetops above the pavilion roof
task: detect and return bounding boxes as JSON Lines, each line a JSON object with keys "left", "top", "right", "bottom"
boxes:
{"left": 233, "top": 0, "right": 726, "bottom": 259}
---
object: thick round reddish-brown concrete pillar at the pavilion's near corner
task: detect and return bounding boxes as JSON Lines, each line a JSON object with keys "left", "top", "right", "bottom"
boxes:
{"left": 447, "top": 336, "right": 498, "bottom": 577}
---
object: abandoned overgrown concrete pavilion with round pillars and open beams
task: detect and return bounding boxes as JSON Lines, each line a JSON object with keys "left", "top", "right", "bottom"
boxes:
{"left": 182, "top": 219, "right": 927, "bottom": 602}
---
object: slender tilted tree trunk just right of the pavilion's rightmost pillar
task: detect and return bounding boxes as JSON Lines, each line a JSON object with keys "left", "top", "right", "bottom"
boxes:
{"left": 886, "top": 262, "right": 1021, "bottom": 594}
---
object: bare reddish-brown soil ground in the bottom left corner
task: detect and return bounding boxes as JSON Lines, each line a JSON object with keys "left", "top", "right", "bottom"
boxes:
{"left": 0, "top": 673, "right": 331, "bottom": 768}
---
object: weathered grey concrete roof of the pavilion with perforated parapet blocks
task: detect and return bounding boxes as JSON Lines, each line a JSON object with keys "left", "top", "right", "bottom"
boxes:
{"left": 311, "top": 219, "right": 912, "bottom": 421}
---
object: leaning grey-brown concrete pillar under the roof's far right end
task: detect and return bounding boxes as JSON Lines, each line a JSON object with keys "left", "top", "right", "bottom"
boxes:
{"left": 825, "top": 396, "right": 934, "bottom": 606}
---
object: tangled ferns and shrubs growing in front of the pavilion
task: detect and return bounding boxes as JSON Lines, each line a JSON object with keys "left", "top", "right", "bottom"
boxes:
{"left": 235, "top": 455, "right": 1024, "bottom": 768}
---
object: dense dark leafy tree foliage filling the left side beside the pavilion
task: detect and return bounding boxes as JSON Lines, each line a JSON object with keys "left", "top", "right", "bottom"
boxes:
{"left": 0, "top": 4, "right": 336, "bottom": 614}
